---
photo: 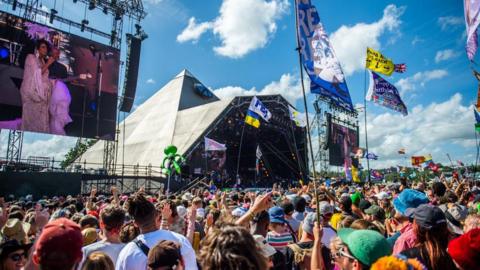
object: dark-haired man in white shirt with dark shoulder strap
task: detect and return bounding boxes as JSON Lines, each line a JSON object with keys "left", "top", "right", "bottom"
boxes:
{"left": 115, "top": 193, "right": 198, "bottom": 270}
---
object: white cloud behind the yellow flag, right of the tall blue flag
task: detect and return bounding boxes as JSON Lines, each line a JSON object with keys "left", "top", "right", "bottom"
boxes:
{"left": 330, "top": 5, "right": 405, "bottom": 76}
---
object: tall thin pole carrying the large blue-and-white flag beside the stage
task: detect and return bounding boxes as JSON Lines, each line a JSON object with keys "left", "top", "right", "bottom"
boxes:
{"left": 294, "top": 0, "right": 320, "bottom": 221}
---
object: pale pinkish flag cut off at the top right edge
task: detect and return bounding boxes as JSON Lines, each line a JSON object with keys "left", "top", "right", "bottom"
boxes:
{"left": 464, "top": 0, "right": 480, "bottom": 61}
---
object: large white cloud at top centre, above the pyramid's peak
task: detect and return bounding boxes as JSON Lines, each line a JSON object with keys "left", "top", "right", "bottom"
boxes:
{"left": 177, "top": 0, "right": 289, "bottom": 58}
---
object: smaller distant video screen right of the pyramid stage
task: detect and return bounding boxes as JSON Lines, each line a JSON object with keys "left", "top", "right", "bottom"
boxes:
{"left": 328, "top": 121, "right": 358, "bottom": 166}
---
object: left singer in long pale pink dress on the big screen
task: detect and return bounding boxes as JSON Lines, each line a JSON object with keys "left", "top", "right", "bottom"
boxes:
{"left": 20, "top": 40, "right": 54, "bottom": 133}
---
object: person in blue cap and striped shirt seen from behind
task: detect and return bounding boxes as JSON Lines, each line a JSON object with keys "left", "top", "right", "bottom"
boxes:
{"left": 267, "top": 206, "right": 294, "bottom": 255}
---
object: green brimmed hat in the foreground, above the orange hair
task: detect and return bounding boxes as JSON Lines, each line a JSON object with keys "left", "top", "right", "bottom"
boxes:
{"left": 338, "top": 228, "right": 392, "bottom": 266}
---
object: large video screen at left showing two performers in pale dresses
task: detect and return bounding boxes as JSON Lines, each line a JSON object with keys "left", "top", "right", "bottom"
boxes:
{"left": 0, "top": 12, "right": 120, "bottom": 140}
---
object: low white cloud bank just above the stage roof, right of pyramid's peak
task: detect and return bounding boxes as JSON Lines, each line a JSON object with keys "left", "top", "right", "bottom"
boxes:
{"left": 213, "top": 73, "right": 308, "bottom": 105}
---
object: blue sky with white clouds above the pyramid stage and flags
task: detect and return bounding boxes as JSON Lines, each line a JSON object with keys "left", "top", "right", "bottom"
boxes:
{"left": 0, "top": 0, "right": 480, "bottom": 168}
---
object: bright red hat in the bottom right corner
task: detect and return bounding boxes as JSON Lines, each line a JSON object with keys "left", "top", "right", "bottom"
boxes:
{"left": 447, "top": 228, "right": 480, "bottom": 270}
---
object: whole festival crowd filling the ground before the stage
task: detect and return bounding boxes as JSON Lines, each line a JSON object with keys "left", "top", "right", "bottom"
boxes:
{"left": 0, "top": 177, "right": 480, "bottom": 270}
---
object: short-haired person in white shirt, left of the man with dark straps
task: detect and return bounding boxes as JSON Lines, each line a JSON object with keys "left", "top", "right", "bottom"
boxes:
{"left": 79, "top": 205, "right": 125, "bottom": 266}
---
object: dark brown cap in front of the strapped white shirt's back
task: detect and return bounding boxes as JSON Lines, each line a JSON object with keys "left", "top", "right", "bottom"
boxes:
{"left": 147, "top": 240, "right": 182, "bottom": 269}
